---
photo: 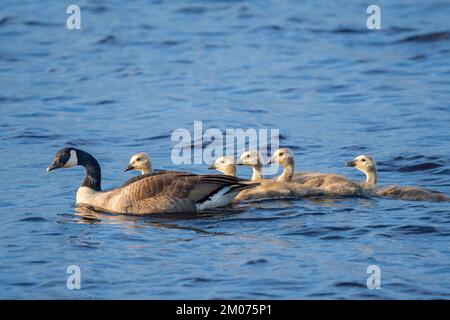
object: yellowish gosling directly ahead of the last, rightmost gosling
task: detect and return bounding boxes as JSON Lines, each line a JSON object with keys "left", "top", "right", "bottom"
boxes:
{"left": 268, "top": 148, "right": 363, "bottom": 196}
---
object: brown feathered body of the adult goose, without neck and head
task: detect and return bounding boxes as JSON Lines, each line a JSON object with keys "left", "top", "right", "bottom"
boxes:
{"left": 77, "top": 171, "right": 254, "bottom": 214}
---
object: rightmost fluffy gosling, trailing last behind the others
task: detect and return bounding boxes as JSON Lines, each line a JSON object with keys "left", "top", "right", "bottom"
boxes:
{"left": 347, "top": 155, "right": 450, "bottom": 201}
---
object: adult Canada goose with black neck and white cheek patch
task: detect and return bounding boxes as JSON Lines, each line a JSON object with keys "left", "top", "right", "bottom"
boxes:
{"left": 47, "top": 148, "right": 258, "bottom": 214}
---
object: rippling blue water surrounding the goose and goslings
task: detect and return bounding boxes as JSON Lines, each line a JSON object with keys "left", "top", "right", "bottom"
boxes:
{"left": 0, "top": 0, "right": 450, "bottom": 299}
